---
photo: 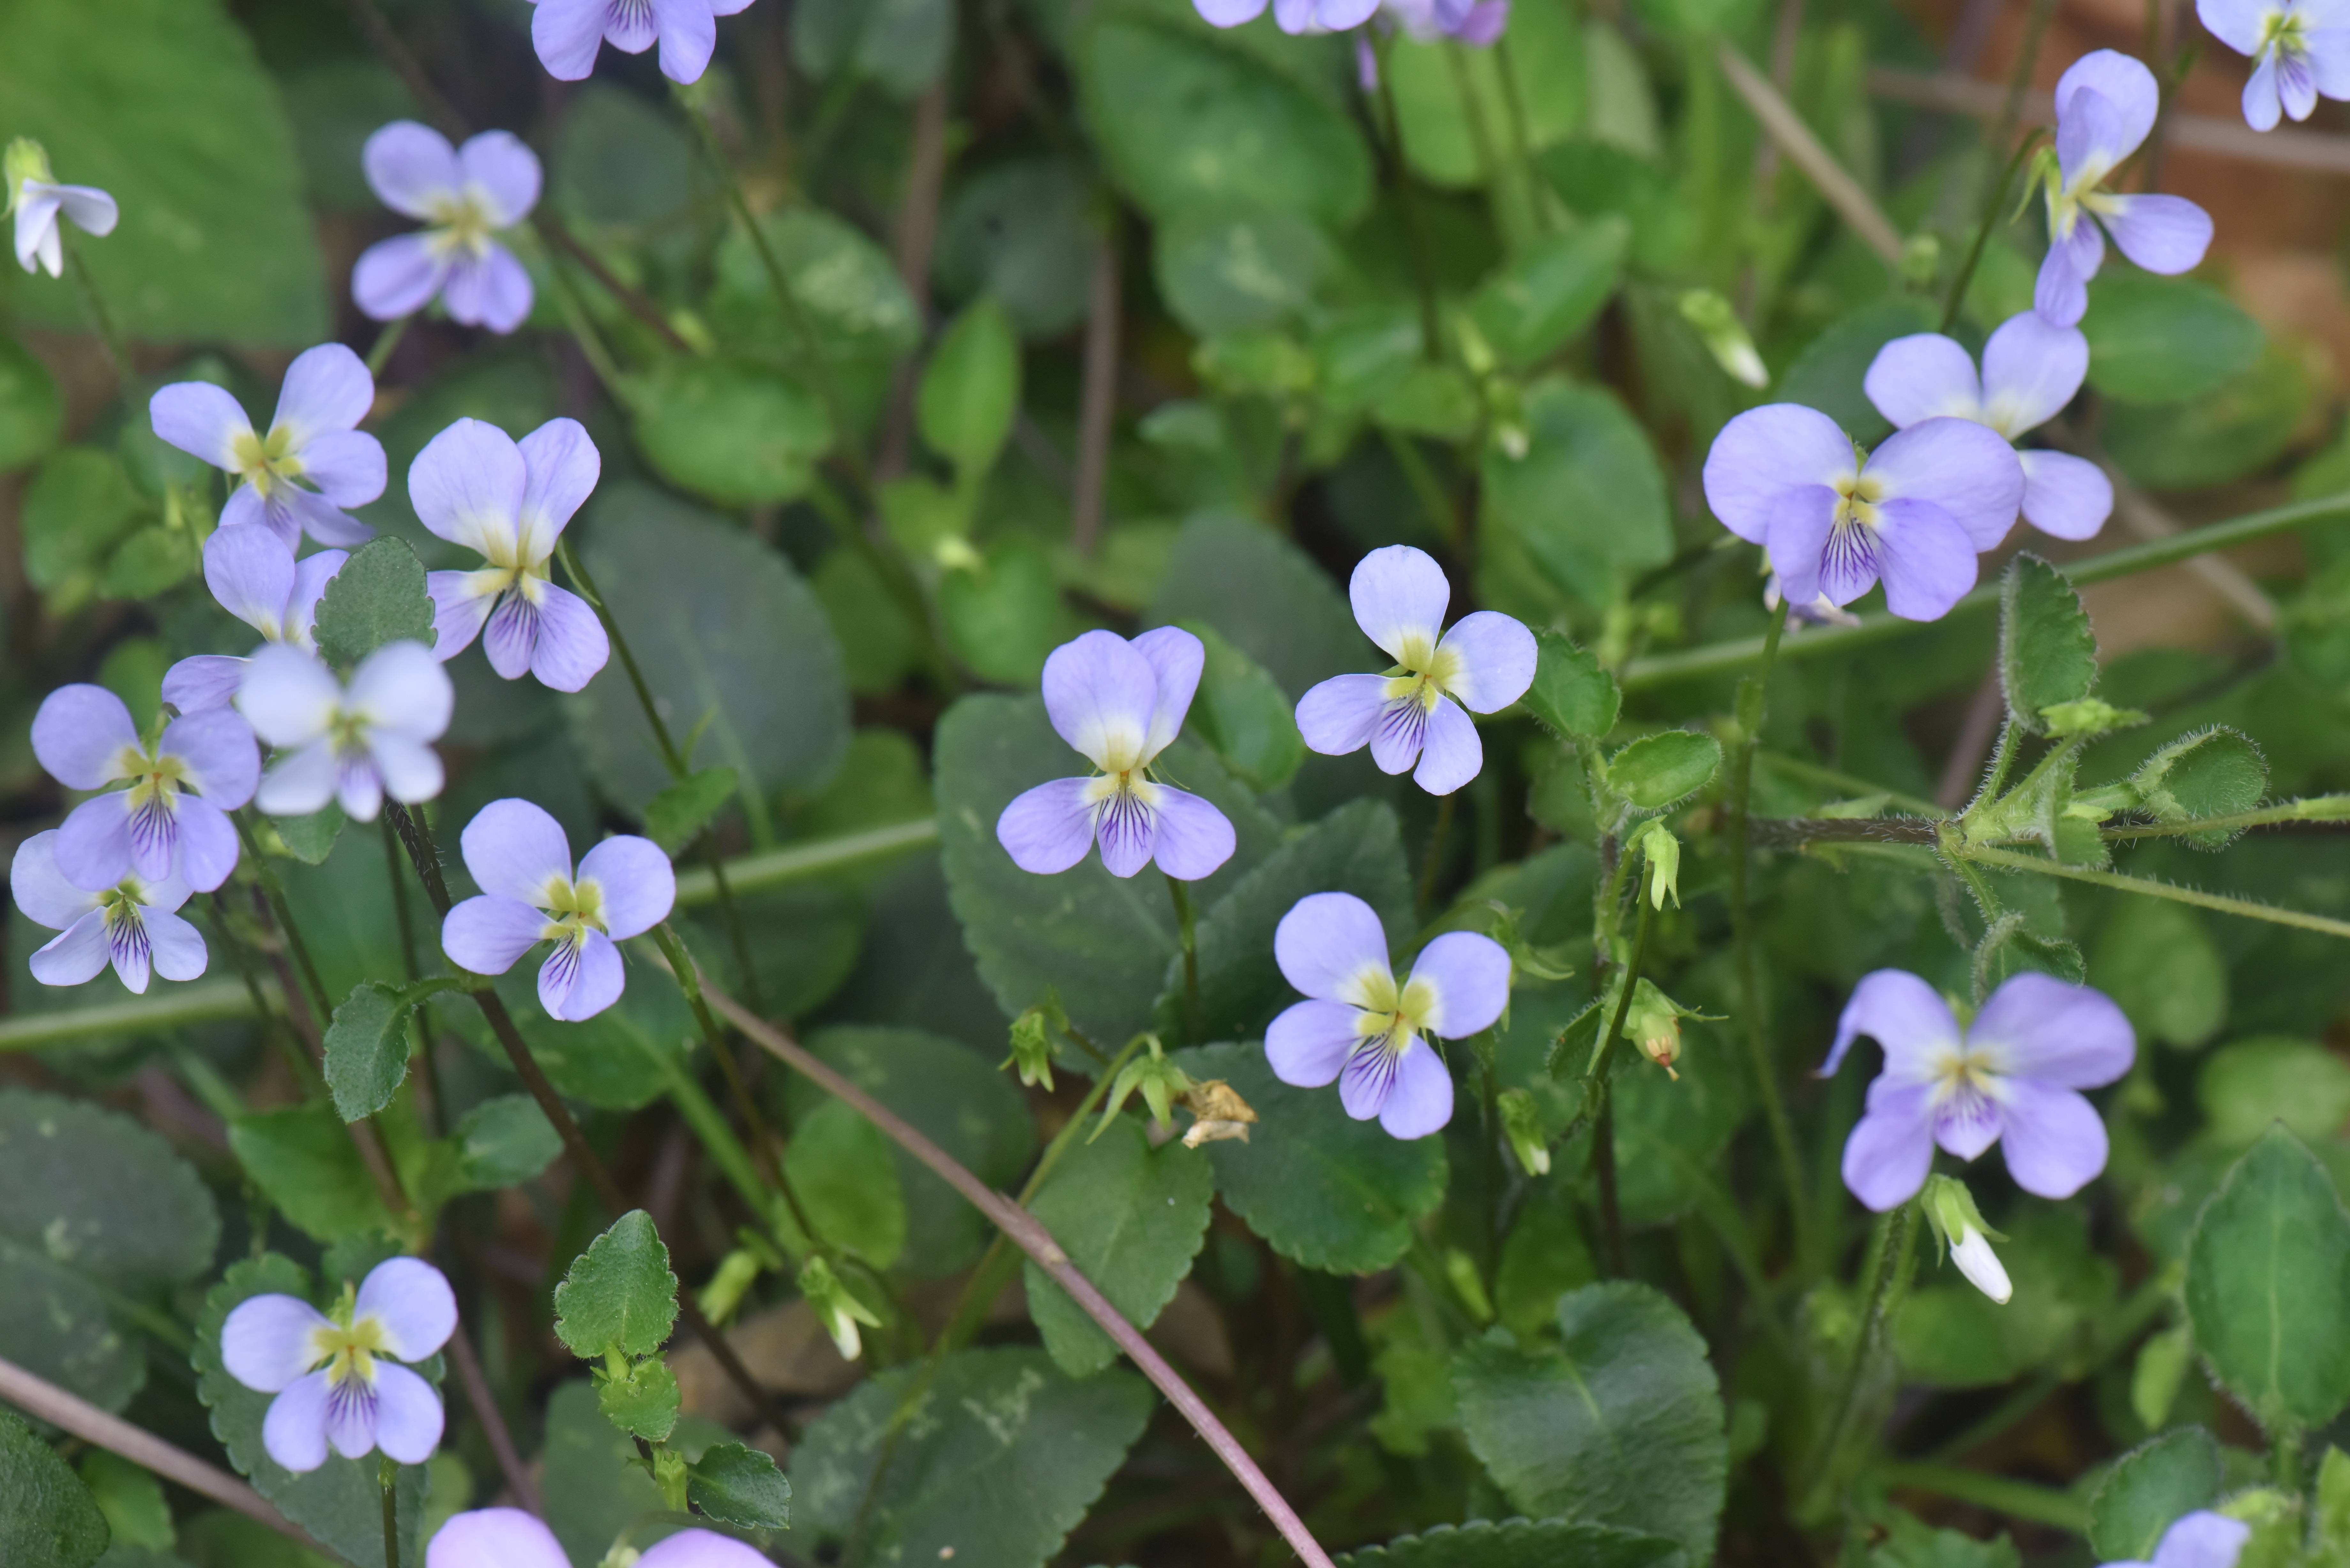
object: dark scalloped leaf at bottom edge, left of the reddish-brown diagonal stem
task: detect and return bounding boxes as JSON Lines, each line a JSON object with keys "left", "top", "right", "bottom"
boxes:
{"left": 792, "top": 1349, "right": 1156, "bottom": 1568}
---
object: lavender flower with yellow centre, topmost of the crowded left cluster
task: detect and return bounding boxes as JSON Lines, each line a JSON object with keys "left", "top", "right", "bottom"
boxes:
{"left": 148, "top": 343, "right": 383, "bottom": 550}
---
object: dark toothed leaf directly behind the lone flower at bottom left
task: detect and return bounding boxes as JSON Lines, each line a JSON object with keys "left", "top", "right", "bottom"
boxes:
{"left": 190, "top": 1260, "right": 439, "bottom": 1563}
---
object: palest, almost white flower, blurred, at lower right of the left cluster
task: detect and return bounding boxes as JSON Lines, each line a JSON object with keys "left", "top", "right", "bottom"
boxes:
{"left": 237, "top": 642, "right": 456, "bottom": 823}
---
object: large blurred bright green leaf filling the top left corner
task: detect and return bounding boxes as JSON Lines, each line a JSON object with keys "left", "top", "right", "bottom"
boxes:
{"left": 0, "top": 0, "right": 331, "bottom": 348}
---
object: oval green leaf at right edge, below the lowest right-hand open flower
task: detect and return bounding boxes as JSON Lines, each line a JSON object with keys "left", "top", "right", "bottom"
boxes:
{"left": 2186, "top": 1126, "right": 2350, "bottom": 1432}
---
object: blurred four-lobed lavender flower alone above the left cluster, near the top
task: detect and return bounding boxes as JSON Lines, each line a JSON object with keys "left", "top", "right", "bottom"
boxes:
{"left": 350, "top": 120, "right": 538, "bottom": 331}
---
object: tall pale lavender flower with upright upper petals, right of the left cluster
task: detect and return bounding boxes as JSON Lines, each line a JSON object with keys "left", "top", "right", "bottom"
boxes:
{"left": 409, "top": 418, "right": 611, "bottom": 691}
